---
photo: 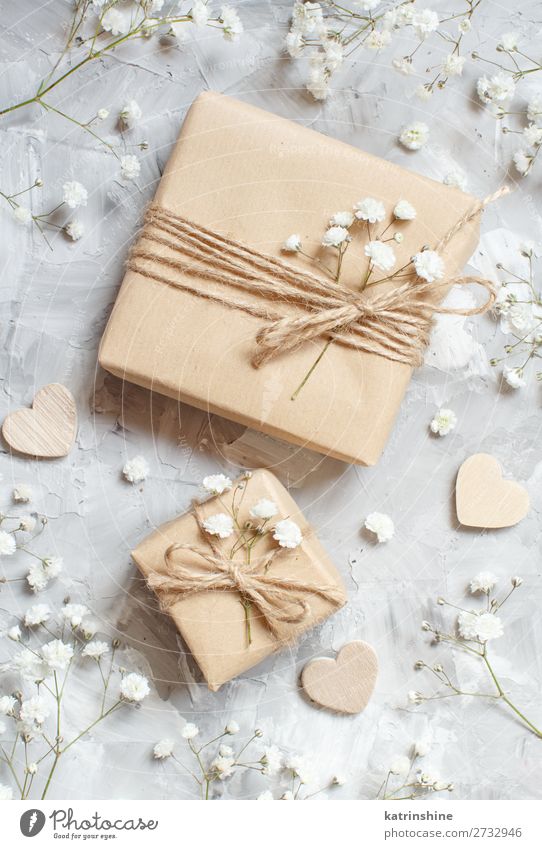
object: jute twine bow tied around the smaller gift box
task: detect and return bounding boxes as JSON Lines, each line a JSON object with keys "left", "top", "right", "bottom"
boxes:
{"left": 147, "top": 506, "right": 344, "bottom": 640}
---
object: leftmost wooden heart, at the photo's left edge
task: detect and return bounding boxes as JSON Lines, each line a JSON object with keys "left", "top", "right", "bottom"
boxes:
{"left": 2, "top": 383, "right": 77, "bottom": 457}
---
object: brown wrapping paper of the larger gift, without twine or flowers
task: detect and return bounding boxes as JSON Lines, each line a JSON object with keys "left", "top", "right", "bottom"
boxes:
{"left": 99, "top": 93, "right": 479, "bottom": 465}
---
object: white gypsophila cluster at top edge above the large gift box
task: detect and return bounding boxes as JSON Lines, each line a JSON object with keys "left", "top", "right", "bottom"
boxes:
{"left": 285, "top": 0, "right": 482, "bottom": 100}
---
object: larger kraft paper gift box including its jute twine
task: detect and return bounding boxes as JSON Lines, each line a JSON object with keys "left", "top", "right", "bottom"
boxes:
{"left": 99, "top": 88, "right": 500, "bottom": 465}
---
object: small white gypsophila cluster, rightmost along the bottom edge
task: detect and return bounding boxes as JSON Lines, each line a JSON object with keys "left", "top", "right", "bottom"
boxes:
{"left": 376, "top": 740, "right": 454, "bottom": 801}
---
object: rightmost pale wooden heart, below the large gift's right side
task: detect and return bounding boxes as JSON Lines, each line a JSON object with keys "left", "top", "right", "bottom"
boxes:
{"left": 455, "top": 454, "right": 529, "bottom": 528}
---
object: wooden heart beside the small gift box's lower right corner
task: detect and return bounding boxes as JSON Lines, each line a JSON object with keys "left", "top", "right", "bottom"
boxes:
{"left": 301, "top": 641, "right": 378, "bottom": 713}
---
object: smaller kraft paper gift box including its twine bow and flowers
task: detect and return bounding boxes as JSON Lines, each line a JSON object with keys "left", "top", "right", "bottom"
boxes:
{"left": 132, "top": 469, "right": 346, "bottom": 690}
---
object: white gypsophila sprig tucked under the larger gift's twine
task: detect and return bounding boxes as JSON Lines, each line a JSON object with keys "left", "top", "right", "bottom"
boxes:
{"left": 282, "top": 197, "right": 445, "bottom": 401}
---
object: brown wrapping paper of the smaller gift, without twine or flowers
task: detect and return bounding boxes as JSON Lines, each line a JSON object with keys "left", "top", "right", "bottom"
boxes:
{"left": 132, "top": 469, "right": 346, "bottom": 690}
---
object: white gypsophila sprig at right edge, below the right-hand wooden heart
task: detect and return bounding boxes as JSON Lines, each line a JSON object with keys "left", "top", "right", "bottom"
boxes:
{"left": 414, "top": 572, "right": 542, "bottom": 737}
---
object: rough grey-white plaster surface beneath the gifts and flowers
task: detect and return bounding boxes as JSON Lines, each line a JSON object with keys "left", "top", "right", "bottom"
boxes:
{"left": 0, "top": 0, "right": 542, "bottom": 799}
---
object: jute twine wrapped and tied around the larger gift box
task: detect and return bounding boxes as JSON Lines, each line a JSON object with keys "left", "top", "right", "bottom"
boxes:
{"left": 128, "top": 186, "right": 509, "bottom": 368}
